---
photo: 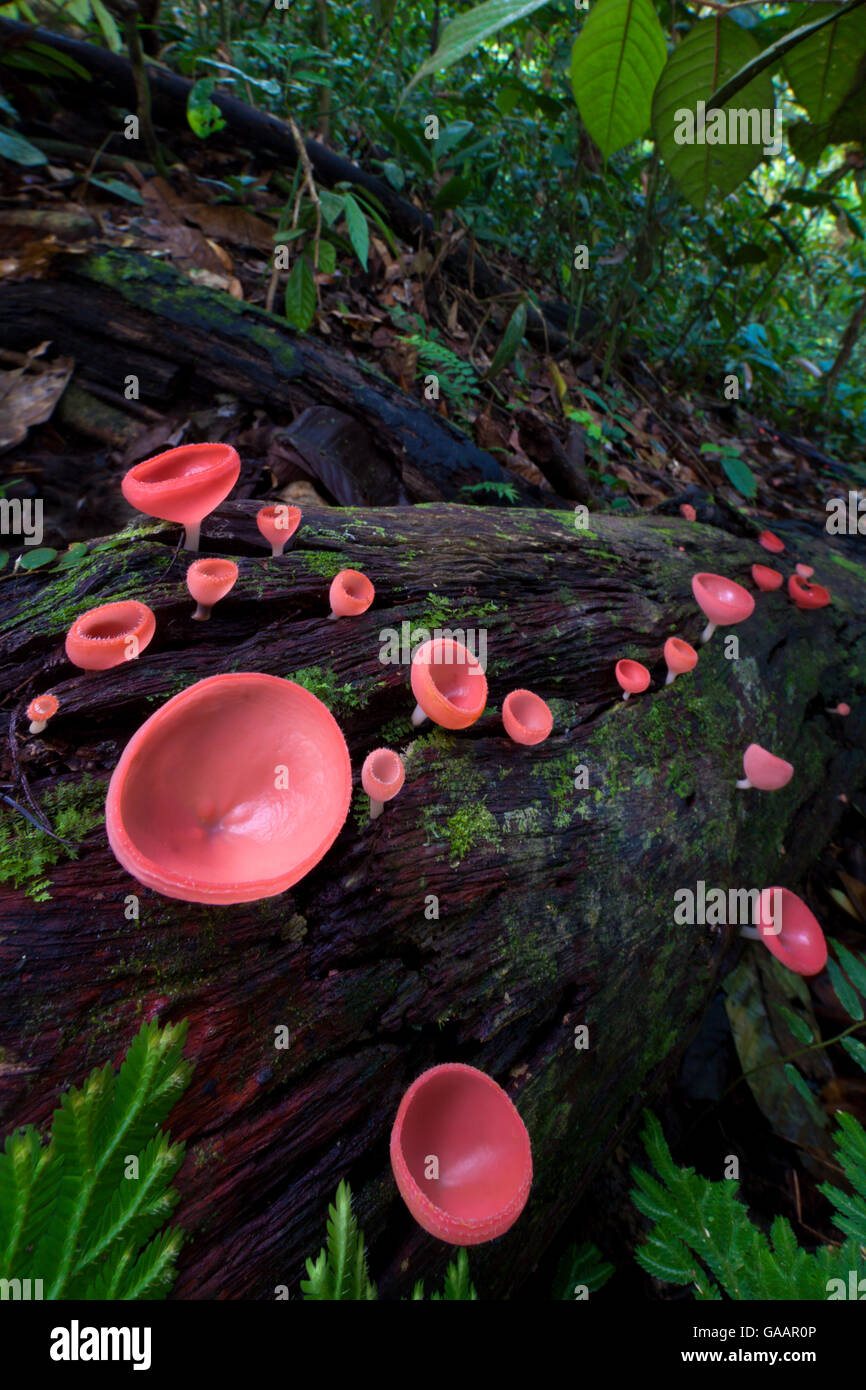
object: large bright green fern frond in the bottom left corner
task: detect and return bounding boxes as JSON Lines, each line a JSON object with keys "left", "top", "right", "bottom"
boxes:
{"left": 0, "top": 1020, "right": 192, "bottom": 1300}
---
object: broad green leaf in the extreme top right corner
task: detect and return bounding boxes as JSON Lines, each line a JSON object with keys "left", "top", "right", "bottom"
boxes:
{"left": 785, "top": 4, "right": 866, "bottom": 125}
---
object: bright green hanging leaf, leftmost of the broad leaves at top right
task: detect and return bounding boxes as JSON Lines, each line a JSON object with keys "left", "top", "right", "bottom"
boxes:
{"left": 571, "top": 0, "right": 667, "bottom": 158}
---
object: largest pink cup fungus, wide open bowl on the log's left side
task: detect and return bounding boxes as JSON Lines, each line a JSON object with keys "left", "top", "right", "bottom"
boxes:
{"left": 106, "top": 673, "right": 352, "bottom": 904}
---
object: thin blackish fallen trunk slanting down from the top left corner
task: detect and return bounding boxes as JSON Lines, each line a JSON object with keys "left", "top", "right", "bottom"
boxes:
{"left": 0, "top": 19, "right": 592, "bottom": 353}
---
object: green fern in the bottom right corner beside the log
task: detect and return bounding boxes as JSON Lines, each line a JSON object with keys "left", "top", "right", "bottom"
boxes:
{"left": 631, "top": 1113, "right": 866, "bottom": 1300}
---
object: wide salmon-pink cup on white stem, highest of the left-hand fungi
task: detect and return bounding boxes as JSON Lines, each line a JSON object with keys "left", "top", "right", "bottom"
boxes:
{"left": 121, "top": 443, "right": 240, "bottom": 550}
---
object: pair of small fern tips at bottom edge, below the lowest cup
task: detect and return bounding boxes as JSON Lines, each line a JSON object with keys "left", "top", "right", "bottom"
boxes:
{"left": 300, "top": 1182, "right": 478, "bottom": 1302}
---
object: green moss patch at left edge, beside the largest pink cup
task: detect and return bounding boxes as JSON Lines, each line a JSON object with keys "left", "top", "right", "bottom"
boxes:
{"left": 0, "top": 776, "right": 106, "bottom": 902}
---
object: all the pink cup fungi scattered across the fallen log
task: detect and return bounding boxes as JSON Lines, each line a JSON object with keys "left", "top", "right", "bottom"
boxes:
{"left": 18, "top": 443, "right": 848, "bottom": 1245}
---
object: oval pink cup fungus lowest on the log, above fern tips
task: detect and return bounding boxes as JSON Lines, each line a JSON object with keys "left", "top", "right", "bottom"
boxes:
{"left": 391, "top": 1062, "right": 532, "bottom": 1245}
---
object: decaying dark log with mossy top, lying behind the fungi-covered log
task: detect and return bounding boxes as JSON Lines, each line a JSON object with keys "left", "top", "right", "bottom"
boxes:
{"left": 0, "top": 250, "right": 555, "bottom": 506}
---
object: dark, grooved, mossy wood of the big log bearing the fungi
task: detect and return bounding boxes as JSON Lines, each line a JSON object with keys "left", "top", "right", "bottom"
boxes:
{"left": 0, "top": 503, "right": 866, "bottom": 1298}
